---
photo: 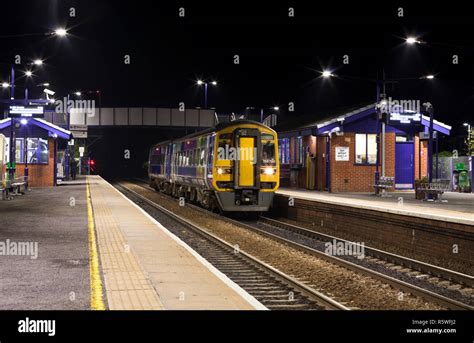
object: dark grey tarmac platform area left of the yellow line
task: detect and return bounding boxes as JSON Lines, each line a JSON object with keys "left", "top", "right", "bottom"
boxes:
{"left": 0, "top": 184, "right": 90, "bottom": 310}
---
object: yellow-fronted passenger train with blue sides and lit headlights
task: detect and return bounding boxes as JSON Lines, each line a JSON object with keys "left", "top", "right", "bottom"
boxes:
{"left": 148, "top": 120, "right": 280, "bottom": 212}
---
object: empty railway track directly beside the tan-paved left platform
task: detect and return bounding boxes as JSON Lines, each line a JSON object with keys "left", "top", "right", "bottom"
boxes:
{"left": 114, "top": 183, "right": 349, "bottom": 310}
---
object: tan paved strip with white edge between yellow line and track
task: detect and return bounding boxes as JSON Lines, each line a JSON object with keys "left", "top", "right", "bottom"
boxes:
{"left": 88, "top": 176, "right": 264, "bottom": 310}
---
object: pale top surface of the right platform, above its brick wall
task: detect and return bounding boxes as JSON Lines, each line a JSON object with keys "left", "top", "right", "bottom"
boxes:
{"left": 277, "top": 188, "right": 474, "bottom": 225}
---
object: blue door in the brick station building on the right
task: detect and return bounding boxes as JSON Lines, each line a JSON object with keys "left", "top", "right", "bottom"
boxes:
{"left": 395, "top": 142, "right": 415, "bottom": 189}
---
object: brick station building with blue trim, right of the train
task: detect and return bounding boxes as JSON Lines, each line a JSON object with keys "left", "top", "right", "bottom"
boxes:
{"left": 275, "top": 104, "right": 451, "bottom": 192}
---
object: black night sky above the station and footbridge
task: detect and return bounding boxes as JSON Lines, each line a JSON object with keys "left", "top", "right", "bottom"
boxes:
{"left": 0, "top": 0, "right": 474, "bottom": 136}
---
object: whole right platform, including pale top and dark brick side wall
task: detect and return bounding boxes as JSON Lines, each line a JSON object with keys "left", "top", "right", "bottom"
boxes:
{"left": 272, "top": 188, "right": 474, "bottom": 275}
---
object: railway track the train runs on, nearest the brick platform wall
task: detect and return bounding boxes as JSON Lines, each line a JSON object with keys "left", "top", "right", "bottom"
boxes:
{"left": 128, "top": 180, "right": 474, "bottom": 310}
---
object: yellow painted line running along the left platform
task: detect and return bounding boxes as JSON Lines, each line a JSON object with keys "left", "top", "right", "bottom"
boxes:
{"left": 86, "top": 177, "right": 105, "bottom": 310}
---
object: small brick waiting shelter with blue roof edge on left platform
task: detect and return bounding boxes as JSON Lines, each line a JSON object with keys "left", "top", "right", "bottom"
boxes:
{"left": 0, "top": 118, "right": 72, "bottom": 187}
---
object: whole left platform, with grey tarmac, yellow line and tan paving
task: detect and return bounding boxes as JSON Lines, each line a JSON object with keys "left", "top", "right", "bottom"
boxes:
{"left": 0, "top": 176, "right": 265, "bottom": 310}
